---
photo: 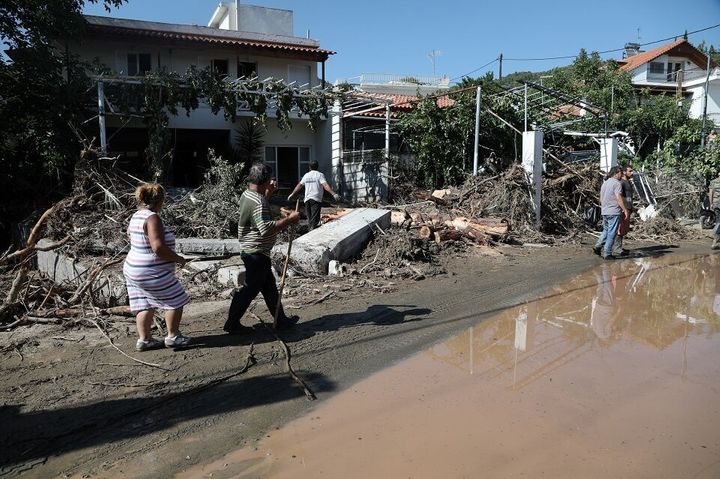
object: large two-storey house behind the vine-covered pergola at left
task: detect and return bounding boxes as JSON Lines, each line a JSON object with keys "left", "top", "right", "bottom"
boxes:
{"left": 68, "top": 2, "right": 335, "bottom": 187}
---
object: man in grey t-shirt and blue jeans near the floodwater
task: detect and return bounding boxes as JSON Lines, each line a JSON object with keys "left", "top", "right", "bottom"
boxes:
{"left": 593, "top": 166, "right": 630, "bottom": 260}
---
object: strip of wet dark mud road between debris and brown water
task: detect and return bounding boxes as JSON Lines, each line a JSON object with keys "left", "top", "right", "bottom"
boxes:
{"left": 0, "top": 243, "right": 709, "bottom": 478}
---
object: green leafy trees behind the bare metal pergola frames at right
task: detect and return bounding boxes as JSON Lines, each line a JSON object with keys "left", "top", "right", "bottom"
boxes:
{"left": 399, "top": 42, "right": 720, "bottom": 187}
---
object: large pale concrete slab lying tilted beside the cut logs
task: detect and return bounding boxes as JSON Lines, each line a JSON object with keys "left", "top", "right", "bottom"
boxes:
{"left": 273, "top": 208, "right": 390, "bottom": 274}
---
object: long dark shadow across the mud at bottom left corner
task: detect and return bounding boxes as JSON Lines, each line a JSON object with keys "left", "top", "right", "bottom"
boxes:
{"left": 0, "top": 368, "right": 335, "bottom": 476}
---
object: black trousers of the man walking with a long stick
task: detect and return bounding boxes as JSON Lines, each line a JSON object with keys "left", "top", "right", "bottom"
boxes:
{"left": 225, "top": 253, "right": 286, "bottom": 329}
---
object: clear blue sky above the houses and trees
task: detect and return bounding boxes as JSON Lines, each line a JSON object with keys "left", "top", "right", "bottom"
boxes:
{"left": 85, "top": 0, "right": 720, "bottom": 81}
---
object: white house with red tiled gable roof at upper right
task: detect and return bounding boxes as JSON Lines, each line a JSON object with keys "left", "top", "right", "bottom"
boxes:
{"left": 619, "top": 38, "right": 720, "bottom": 128}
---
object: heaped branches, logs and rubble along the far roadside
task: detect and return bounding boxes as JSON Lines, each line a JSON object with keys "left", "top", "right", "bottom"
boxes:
{"left": 0, "top": 145, "right": 702, "bottom": 329}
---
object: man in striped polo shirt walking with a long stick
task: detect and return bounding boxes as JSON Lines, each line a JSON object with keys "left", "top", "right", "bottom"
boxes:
{"left": 223, "top": 163, "right": 300, "bottom": 334}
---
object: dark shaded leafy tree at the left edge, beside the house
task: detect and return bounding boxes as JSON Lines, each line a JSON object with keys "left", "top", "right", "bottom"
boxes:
{"left": 0, "top": 0, "right": 125, "bottom": 243}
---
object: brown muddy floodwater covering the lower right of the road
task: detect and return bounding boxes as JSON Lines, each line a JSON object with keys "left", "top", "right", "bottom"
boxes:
{"left": 180, "top": 255, "right": 720, "bottom": 479}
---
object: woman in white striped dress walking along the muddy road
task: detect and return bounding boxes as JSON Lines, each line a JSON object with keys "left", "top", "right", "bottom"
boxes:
{"left": 123, "top": 183, "right": 190, "bottom": 351}
